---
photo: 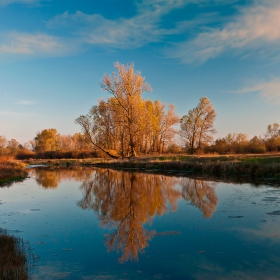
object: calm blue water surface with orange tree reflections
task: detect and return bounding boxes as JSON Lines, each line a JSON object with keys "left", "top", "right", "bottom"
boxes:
{"left": 0, "top": 168, "right": 280, "bottom": 280}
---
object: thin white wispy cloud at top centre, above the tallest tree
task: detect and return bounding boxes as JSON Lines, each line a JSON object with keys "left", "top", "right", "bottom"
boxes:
{"left": 47, "top": 0, "right": 230, "bottom": 49}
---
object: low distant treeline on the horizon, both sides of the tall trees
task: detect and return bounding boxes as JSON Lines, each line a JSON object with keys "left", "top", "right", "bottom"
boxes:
{"left": 0, "top": 123, "right": 280, "bottom": 159}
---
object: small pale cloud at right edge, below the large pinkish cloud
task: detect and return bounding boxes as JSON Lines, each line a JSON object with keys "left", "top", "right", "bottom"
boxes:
{"left": 232, "top": 77, "right": 280, "bottom": 103}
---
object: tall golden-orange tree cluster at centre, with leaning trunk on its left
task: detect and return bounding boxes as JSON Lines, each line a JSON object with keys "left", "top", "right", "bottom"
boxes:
{"left": 76, "top": 63, "right": 179, "bottom": 158}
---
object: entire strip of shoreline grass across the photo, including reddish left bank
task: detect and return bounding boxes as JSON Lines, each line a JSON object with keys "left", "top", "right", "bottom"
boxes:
{"left": 0, "top": 153, "right": 280, "bottom": 187}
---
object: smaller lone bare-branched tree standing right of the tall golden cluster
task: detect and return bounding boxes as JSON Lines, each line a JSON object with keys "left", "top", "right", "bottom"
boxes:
{"left": 180, "top": 97, "right": 216, "bottom": 153}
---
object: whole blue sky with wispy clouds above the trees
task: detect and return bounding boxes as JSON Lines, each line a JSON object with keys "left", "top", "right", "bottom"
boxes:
{"left": 0, "top": 0, "right": 280, "bottom": 144}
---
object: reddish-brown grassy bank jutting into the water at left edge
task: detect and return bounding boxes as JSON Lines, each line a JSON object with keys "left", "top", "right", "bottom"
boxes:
{"left": 0, "top": 157, "right": 27, "bottom": 186}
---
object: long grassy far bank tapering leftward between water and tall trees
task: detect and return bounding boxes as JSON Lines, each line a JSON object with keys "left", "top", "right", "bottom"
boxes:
{"left": 23, "top": 154, "right": 280, "bottom": 181}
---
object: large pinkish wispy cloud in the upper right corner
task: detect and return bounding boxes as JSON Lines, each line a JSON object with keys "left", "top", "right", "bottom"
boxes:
{"left": 169, "top": 0, "right": 280, "bottom": 63}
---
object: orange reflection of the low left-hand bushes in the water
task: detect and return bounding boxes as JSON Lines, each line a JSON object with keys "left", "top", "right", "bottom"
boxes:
{"left": 33, "top": 167, "right": 94, "bottom": 189}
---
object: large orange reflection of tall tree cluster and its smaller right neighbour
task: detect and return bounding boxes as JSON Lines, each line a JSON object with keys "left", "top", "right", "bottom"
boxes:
{"left": 78, "top": 169, "right": 218, "bottom": 262}
